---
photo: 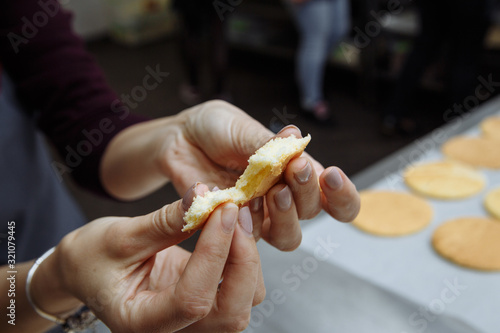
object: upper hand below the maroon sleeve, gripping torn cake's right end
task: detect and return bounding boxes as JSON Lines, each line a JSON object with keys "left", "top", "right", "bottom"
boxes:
{"left": 158, "top": 101, "right": 359, "bottom": 250}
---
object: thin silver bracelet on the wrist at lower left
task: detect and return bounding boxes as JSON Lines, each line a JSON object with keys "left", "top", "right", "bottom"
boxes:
{"left": 26, "top": 246, "right": 98, "bottom": 332}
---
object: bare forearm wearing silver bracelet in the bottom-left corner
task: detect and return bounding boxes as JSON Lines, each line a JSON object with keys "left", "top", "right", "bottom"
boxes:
{"left": 0, "top": 250, "right": 81, "bottom": 333}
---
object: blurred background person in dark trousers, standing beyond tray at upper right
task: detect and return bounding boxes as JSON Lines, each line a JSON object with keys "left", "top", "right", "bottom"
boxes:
{"left": 381, "top": 0, "right": 490, "bottom": 136}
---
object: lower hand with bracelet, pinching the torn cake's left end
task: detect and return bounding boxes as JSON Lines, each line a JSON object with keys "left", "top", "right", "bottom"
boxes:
{"left": 33, "top": 184, "right": 265, "bottom": 332}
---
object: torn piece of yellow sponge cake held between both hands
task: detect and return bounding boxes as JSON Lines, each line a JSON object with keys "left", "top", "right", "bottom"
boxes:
{"left": 182, "top": 135, "right": 311, "bottom": 231}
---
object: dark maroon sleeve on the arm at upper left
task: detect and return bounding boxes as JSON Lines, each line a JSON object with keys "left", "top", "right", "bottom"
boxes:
{"left": 0, "top": 0, "right": 149, "bottom": 193}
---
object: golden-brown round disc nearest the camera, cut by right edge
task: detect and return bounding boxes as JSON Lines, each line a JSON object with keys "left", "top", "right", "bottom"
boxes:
{"left": 432, "top": 217, "right": 500, "bottom": 271}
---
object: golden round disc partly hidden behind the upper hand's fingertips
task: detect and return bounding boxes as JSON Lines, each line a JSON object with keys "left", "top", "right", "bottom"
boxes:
{"left": 353, "top": 191, "right": 432, "bottom": 236}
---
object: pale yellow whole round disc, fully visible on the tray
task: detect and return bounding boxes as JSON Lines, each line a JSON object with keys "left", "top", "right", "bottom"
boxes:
{"left": 404, "top": 161, "right": 485, "bottom": 199}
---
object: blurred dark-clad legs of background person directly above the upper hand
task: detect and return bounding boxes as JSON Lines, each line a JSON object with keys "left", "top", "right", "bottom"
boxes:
{"left": 173, "top": 0, "right": 231, "bottom": 106}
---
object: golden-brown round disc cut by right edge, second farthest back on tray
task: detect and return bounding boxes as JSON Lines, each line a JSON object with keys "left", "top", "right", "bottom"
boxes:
{"left": 442, "top": 136, "right": 500, "bottom": 169}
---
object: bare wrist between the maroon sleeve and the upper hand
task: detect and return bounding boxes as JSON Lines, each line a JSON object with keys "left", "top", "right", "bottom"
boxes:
{"left": 100, "top": 114, "right": 185, "bottom": 200}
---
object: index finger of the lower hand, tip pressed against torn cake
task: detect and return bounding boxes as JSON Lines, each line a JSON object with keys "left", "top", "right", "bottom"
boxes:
{"left": 175, "top": 203, "right": 238, "bottom": 322}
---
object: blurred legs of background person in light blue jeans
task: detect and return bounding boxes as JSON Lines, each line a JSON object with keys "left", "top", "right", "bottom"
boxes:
{"left": 285, "top": 0, "right": 351, "bottom": 123}
